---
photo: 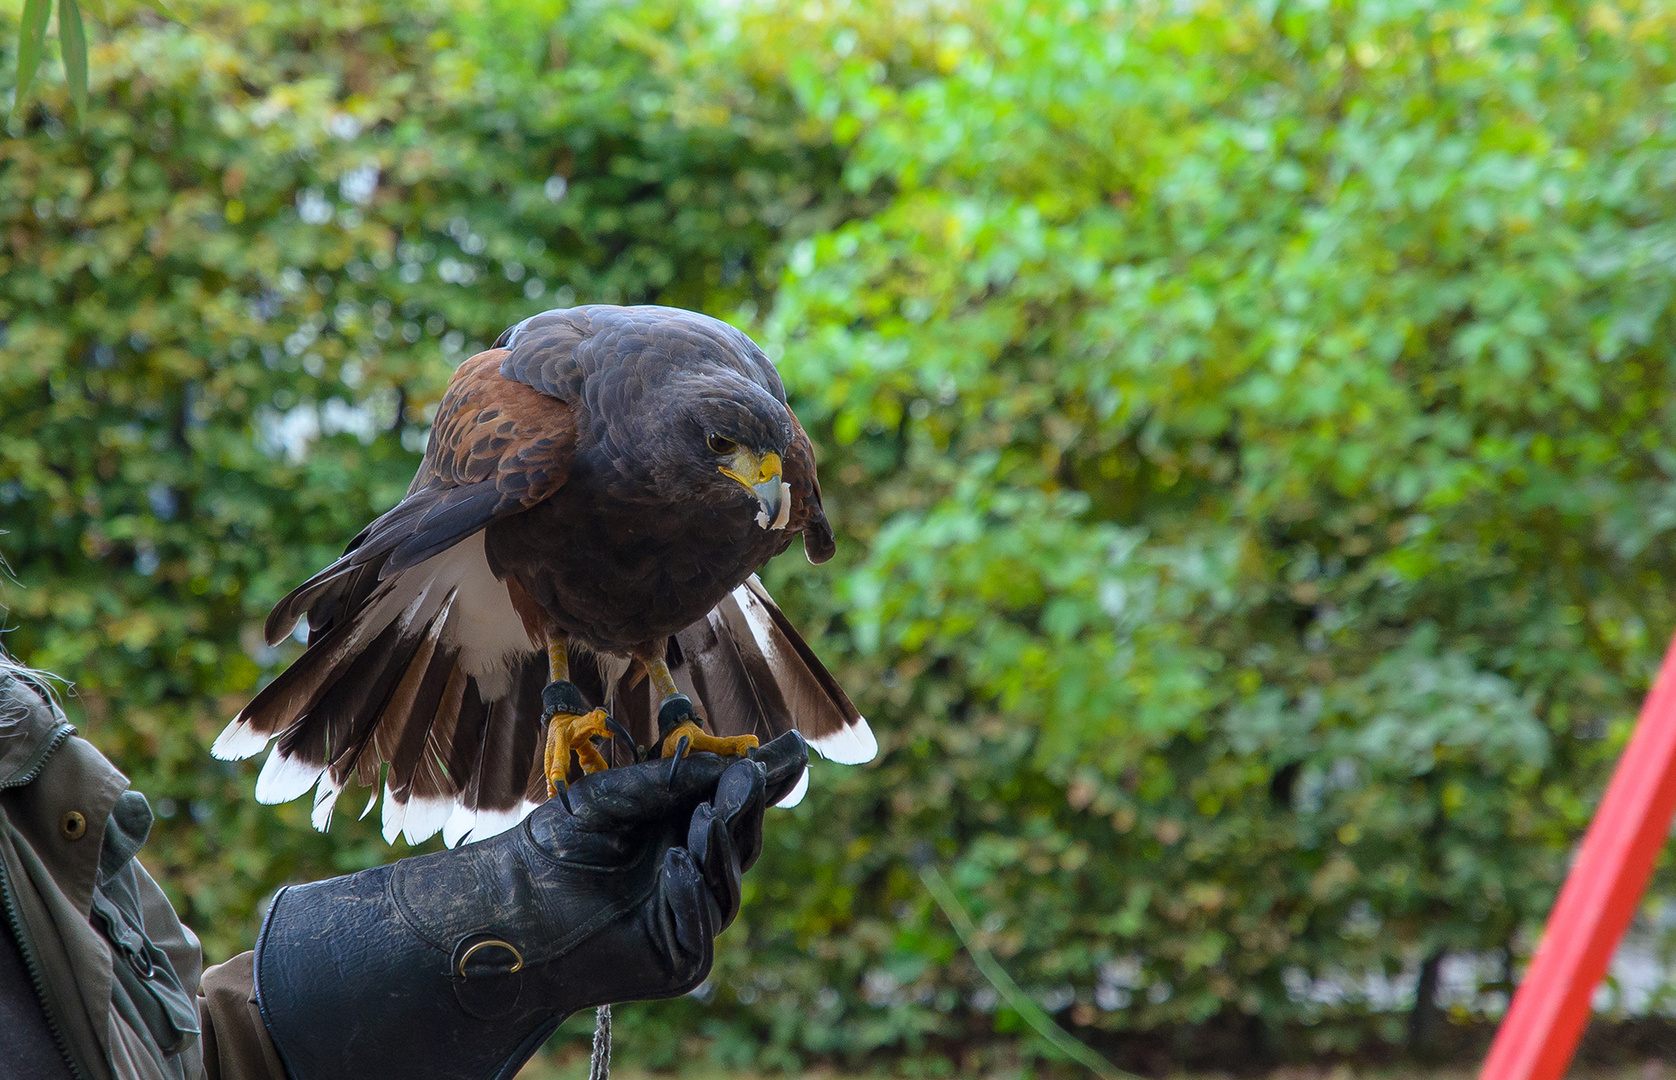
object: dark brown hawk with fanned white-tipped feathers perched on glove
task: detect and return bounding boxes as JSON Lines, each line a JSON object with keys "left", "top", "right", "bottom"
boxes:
{"left": 211, "top": 305, "right": 877, "bottom": 845}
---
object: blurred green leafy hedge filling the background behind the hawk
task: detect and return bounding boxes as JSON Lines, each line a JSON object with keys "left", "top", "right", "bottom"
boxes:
{"left": 0, "top": 0, "right": 1676, "bottom": 1075}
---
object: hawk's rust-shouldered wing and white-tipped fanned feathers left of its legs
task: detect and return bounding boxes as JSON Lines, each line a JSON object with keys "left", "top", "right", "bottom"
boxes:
{"left": 213, "top": 349, "right": 578, "bottom": 842}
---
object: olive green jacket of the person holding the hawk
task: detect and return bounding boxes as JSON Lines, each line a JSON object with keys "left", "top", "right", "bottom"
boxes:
{"left": 0, "top": 669, "right": 285, "bottom": 1080}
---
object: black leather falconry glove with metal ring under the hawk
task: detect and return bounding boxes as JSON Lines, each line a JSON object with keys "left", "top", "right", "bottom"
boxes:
{"left": 255, "top": 731, "right": 808, "bottom": 1080}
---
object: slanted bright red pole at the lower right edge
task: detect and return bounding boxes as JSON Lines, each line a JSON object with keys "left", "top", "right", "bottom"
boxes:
{"left": 1478, "top": 641, "right": 1676, "bottom": 1080}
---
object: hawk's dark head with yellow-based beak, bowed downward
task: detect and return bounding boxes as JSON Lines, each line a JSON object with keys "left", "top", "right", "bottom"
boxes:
{"left": 685, "top": 379, "right": 793, "bottom": 528}
